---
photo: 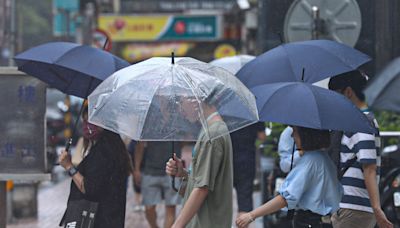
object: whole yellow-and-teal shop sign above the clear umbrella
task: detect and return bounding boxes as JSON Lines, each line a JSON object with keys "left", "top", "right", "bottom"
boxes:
{"left": 98, "top": 15, "right": 222, "bottom": 41}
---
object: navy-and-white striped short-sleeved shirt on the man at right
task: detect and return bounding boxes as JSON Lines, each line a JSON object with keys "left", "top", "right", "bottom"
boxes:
{"left": 340, "top": 110, "right": 381, "bottom": 213}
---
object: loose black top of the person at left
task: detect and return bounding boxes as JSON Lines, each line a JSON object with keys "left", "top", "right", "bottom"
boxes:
{"left": 68, "top": 134, "right": 127, "bottom": 228}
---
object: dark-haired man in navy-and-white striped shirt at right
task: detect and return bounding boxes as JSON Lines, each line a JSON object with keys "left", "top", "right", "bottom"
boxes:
{"left": 328, "top": 70, "right": 393, "bottom": 228}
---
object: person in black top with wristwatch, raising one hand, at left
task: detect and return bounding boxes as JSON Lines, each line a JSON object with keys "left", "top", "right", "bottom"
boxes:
{"left": 59, "top": 107, "right": 132, "bottom": 228}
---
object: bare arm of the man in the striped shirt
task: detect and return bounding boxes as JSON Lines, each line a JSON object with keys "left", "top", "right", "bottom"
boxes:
{"left": 363, "top": 164, "right": 393, "bottom": 228}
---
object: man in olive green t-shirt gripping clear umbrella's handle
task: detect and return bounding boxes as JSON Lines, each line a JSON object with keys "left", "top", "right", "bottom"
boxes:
{"left": 166, "top": 97, "right": 233, "bottom": 228}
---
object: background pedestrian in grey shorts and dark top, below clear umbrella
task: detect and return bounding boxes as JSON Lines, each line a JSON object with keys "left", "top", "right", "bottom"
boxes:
{"left": 133, "top": 141, "right": 181, "bottom": 228}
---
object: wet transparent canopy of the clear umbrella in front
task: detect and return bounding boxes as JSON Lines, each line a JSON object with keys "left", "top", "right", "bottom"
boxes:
{"left": 89, "top": 57, "right": 258, "bottom": 141}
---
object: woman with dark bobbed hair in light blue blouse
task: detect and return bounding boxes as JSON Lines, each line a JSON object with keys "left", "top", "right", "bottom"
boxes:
{"left": 236, "top": 126, "right": 343, "bottom": 228}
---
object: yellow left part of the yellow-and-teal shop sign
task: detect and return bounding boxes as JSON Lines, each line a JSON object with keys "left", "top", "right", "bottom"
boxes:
{"left": 98, "top": 15, "right": 172, "bottom": 41}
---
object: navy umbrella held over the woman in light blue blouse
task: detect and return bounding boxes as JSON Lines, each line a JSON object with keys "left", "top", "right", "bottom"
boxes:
{"left": 250, "top": 82, "right": 376, "bottom": 133}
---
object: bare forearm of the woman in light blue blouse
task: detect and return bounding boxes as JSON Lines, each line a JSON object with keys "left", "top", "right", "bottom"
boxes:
{"left": 236, "top": 195, "right": 287, "bottom": 227}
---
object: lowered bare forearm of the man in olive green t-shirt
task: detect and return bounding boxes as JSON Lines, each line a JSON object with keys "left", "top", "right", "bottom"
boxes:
{"left": 172, "top": 188, "right": 208, "bottom": 228}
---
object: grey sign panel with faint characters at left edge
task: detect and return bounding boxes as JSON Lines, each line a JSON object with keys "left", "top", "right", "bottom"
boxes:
{"left": 0, "top": 70, "right": 46, "bottom": 174}
